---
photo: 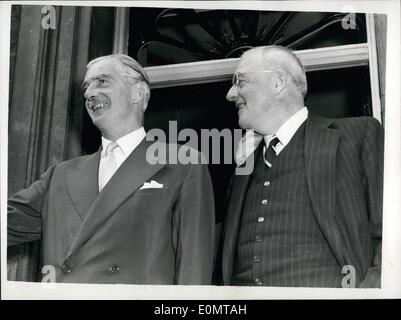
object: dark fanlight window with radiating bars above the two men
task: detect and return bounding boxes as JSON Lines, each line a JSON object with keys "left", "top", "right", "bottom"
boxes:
{"left": 128, "top": 8, "right": 366, "bottom": 66}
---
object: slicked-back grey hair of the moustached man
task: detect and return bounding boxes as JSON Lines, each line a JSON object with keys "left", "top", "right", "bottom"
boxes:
{"left": 86, "top": 53, "right": 150, "bottom": 101}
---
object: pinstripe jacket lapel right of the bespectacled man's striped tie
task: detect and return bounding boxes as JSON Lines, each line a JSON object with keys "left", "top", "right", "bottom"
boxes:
{"left": 304, "top": 113, "right": 345, "bottom": 266}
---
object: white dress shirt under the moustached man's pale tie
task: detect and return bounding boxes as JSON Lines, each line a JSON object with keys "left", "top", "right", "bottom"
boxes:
{"left": 99, "top": 127, "right": 146, "bottom": 191}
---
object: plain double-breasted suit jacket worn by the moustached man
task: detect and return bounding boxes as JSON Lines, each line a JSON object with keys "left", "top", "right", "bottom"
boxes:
{"left": 8, "top": 140, "right": 215, "bottom": 284}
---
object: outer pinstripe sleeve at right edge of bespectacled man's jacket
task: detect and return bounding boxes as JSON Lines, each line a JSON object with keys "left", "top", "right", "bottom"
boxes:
{"left": 360, "top": 119, "right": 384, "bottom": 288}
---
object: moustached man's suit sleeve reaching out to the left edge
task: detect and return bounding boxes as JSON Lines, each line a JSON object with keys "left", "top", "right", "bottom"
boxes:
{"left": 7, "top": 166, "right": 54, "bottom": 246}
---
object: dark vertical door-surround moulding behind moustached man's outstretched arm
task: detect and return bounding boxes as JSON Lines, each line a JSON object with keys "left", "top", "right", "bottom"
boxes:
{"left": 7, "top": 6, "right": 91, "bottom": 281}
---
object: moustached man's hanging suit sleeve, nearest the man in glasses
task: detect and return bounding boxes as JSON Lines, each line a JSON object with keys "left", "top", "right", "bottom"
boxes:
{"left": 175, "top": 161, "right": 215, "bottom": 285}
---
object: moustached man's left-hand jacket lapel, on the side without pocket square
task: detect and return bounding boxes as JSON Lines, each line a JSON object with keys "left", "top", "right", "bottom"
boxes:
{"left": 66, "top": 150, "right": 100, "bottom": 220}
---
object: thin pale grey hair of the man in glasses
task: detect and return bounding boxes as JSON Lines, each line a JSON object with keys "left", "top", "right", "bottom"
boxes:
{"left": 244, "top": 45, "right": 308, "bottom": 98}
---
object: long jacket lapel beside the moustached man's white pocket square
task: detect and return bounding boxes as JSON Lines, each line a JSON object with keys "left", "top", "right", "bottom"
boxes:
{"left": 67, "top": 139, "right": 165, "bottom": 258}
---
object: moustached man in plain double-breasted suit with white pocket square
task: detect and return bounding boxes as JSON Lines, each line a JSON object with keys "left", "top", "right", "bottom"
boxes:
{"left": 8, "top": 54, "right": 215, "bottom": 285}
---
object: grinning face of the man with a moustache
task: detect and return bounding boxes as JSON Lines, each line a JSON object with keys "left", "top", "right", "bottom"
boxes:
{"left": 83, "top": 59, "right": 135, "bottom": 134}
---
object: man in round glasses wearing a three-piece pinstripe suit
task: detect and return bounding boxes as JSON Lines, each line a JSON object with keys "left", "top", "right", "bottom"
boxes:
{"left": 221, "top": 46, "right": 383, "bottom": 287}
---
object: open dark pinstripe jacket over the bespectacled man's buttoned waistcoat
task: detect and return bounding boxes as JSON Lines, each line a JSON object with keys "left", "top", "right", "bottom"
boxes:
{"left": 221, "top": 113, "right": 384, "bottom": 287}
